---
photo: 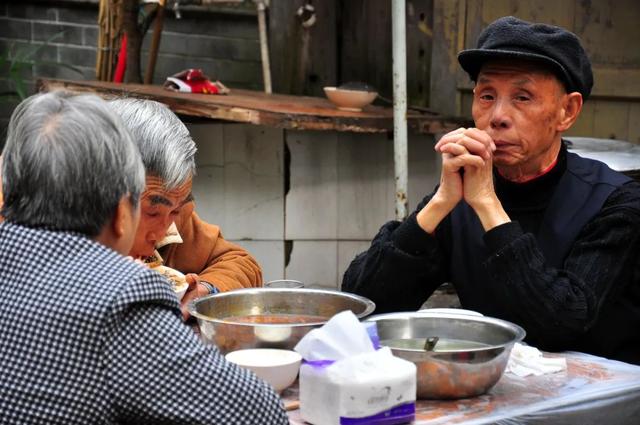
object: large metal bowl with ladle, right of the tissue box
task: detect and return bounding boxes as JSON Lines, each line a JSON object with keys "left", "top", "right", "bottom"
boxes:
{"left": 367, "top": 312, "right": 525, "bottom": 399}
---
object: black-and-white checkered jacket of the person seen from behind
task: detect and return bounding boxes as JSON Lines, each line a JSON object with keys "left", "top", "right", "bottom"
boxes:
{"left": 0, "top": 222, "right": 288, "bottom": 425}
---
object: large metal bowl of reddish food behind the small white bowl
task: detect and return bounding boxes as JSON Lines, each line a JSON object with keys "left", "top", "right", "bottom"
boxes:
{"left": 189, "top": 288, "right": 375, "bottom": 353}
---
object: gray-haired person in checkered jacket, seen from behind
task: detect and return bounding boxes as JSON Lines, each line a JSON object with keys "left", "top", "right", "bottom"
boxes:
{"left": 0, "top": 92, "right": 288, "bottom": 425}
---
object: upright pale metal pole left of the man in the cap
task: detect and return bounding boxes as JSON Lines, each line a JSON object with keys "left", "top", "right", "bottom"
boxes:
{"left": 391, "top": 0, "right": 409, "bottom": 220}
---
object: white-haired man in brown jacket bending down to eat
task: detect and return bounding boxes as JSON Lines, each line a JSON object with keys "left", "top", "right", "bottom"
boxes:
{"left": 110, "top": 98, "right": 262, "bottom": 318}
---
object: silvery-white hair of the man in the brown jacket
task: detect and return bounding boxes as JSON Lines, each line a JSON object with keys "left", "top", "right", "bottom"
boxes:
{"left": 110, "top": 98, "right": 197, "bottom": 190}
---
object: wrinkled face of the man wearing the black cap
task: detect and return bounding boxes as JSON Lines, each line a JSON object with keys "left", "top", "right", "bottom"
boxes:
{"left": 472, "top": 61, "right": 566, "bottom": 172}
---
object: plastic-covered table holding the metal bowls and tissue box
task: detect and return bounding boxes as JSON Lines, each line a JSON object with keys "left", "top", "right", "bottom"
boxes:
{"left": 282, "top": 352, "right": 640, "bottom": 425}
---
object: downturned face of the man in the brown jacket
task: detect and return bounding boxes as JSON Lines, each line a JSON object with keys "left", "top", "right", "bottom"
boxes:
{"left": 129, "top": 175, "right": 193, "bottom": 258}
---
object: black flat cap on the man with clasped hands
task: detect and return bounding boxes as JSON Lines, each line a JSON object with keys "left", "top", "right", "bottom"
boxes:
{"left": 458, "top": 16, "right": 593, "bottom": 100}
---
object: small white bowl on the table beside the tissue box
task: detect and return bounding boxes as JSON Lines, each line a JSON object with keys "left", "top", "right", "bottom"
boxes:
{"left": 225, "top": 348, "right": 302, "bottom": 392}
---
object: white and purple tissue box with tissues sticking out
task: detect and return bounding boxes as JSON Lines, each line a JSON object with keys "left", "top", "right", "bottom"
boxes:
{"left": 295, "top": 311, "right": 416, "bottom": 425}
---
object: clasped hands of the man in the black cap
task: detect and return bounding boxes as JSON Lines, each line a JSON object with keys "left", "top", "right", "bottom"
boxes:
{"left": 416, "top": 128, "right": 510, "bottom": 233}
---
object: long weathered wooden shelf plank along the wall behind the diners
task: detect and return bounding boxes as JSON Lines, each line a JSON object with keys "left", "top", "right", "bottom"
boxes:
{"left": 38, "top": 80, "right": 465, "bottom": 133}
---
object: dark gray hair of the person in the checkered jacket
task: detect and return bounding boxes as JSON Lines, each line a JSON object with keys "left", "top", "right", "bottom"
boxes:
{"left": 2, "top": 91, "right": 145, "bottom": 237}
